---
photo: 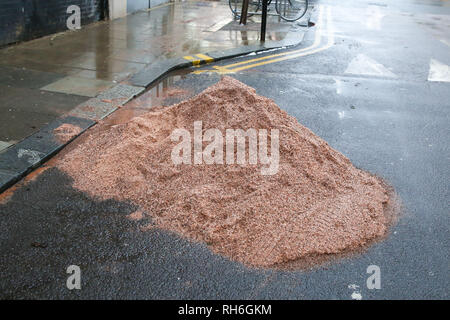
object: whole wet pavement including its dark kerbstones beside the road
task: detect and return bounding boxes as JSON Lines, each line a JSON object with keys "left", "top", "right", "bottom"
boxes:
{"left": 0, "top": 0, "right": 313, "bottom": 192}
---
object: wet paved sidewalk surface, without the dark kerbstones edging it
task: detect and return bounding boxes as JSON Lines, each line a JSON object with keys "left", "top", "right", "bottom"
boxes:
{"left": 0, "top": 1, "right": 310, "bottom": 148}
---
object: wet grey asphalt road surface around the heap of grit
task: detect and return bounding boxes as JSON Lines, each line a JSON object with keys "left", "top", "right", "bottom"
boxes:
{"left": 0, "top": 1, "right": 450, "bottom": 299}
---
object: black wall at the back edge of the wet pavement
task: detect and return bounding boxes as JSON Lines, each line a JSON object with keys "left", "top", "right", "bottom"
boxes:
{"left": 0, "top": 0, "right": 108, "bottom": 46}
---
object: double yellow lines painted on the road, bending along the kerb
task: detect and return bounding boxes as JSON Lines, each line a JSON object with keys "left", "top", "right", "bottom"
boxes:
{"left": 194, "top": 5, "right": 334, "bottom": 74}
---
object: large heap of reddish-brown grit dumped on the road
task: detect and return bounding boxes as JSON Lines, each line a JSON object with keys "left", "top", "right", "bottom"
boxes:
{"left": 58, "top": 77, "right": 391, "bottom": 267}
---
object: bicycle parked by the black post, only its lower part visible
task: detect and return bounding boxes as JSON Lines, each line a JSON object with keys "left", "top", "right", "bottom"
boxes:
{"left": 228, "top": 0, "right": 308, "bottom": 22}
